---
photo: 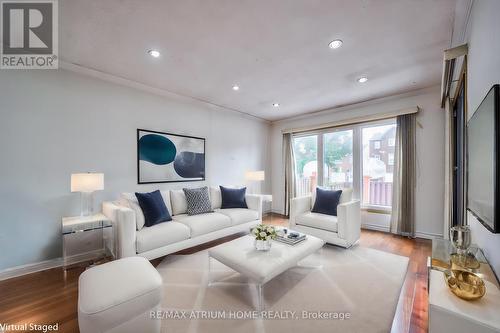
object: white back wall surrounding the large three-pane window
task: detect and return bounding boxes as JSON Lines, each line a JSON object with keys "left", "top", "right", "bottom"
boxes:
{"left": 271, "top": 86, "right": 444, "bottom": 237}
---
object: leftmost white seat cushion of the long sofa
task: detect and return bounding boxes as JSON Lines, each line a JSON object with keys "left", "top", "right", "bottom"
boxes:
{"left": 136, "top": 221, "right": 191, "bottom": 253}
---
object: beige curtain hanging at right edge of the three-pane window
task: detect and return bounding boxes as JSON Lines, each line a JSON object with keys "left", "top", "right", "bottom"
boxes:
{"left": 390, "top": 114, "right": 417, "bottom": 237}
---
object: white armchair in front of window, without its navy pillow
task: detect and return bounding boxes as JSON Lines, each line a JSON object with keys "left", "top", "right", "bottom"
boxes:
{"left": 290, "top": 188, "right": 361, "bottom": 248}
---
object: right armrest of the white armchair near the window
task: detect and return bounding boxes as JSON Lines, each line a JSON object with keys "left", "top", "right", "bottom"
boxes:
{"left": 337, "top": 200, "right": 361, "bottom": 246}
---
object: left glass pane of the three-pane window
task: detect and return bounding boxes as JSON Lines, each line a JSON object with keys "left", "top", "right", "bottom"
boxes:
{"left": 293, "top": 135, "right": 318, "bottom": 197}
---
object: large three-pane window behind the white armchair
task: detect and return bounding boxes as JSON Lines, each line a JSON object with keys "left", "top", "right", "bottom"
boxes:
{"left": 293, "top": 119, "right": 396, "bottom": 211}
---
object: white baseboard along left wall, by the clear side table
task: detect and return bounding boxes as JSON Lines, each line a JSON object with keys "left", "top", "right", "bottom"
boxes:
{"left": 0, "top": 250, "right": 102, "bottom": 281}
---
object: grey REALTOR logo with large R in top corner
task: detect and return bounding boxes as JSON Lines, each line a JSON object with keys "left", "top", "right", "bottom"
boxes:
{"left": 0, "top": 0, "right": 59, "bottom": 69}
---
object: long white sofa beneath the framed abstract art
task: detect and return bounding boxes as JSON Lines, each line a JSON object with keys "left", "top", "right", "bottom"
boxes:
{"left": 103, "top": 187, "right": 262, "bottom": 260}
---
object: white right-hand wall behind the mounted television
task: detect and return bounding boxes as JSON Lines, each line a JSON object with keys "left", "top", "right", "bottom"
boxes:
{"left": 458, "top": 0, "right": 500, "bottom": 275}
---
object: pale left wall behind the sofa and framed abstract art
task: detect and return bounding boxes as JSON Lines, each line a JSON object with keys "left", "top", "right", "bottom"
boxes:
{"left": 0, "top": 70, "right": 270, "bottom": 270}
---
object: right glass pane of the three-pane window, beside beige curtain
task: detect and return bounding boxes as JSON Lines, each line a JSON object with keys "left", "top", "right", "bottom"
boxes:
{"left": 362, "top": 124, "right": 396, "bottom": 207}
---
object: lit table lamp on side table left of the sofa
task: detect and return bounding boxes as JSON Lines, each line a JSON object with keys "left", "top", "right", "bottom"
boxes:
{"left": 71, "top": 172, "right": 104, "bottom": 216}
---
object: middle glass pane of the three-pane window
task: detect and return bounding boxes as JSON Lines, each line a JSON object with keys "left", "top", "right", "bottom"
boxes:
{"left": 323, "top": 130, "right": 353, "bottom": 189}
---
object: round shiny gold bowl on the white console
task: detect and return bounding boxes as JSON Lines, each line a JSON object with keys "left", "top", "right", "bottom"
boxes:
{"left": 444, "top": 269, "right": 486, "bottom": 301}
